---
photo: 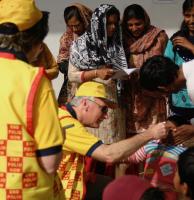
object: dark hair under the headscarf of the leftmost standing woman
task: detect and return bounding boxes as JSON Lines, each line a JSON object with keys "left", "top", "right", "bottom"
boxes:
{"left": 64, "top": 6, "right": 83, "bottom": 24}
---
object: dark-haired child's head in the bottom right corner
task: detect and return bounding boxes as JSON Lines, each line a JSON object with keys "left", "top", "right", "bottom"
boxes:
{"left": 174, "top": 147, "right": 194, "bottom": 200}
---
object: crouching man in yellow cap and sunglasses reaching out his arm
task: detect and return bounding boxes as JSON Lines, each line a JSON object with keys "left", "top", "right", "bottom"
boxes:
{"left": 58, "top": 81, "right": 168, "bottom": 200}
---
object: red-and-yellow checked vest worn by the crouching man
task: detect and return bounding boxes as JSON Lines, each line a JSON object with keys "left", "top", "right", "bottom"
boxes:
{"left": 58, "top": 107, "right": 86, "bottom": 200}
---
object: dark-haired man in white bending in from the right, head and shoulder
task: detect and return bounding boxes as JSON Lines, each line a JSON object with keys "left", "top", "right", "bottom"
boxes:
{"left": 140, "top": 53, "right": 194, "bottom": 103}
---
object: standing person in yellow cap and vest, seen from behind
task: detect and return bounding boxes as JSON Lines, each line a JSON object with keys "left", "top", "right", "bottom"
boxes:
{"left": 0, "top": 0, "right": 63, "bottom": 200}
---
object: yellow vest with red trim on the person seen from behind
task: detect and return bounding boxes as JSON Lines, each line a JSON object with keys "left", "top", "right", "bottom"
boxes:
{"left": 0, "top": 52, "right": 60, "bottom": 200}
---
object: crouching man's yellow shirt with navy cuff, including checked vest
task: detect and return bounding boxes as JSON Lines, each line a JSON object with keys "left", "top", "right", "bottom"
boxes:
{"left": 58, "top": 105, "right": 102, "bottom": 200}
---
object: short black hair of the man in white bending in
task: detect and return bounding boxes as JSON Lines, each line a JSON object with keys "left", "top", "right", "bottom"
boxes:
{"left": 140, "top": 55, "right": 179, "bottom": 91}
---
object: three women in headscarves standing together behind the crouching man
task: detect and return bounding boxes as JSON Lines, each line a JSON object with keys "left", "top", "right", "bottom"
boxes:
{"left": 55, "top": 4, "right": 168, "bottom": 144}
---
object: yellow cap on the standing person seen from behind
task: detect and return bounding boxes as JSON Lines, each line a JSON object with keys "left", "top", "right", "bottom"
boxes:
{"left": 0, "top": 0, "right": 42, "bottom": 31}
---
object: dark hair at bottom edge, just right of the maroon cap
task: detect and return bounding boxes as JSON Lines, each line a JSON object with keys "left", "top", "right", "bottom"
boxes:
{"left": 140, "top": 187, "right": 165, "bottom": 200}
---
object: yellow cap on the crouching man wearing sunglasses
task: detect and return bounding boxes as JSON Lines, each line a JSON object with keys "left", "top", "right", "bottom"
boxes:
{"left": 75, "top": 81, "right": 117, "bottom": 108}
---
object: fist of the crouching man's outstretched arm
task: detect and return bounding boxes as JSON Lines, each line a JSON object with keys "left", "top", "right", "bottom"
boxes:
{"left": 147, "top": 122, "right": 167, "bottom": 140}
